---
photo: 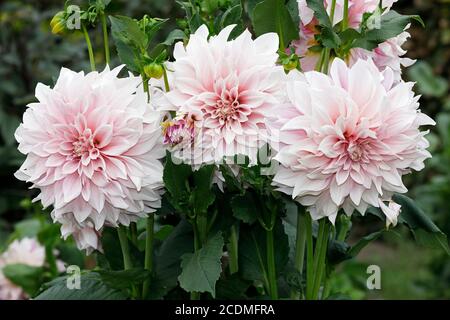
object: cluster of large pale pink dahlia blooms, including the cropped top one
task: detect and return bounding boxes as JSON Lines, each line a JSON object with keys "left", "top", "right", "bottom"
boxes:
{"left": 16, "top": 0, "right": 434, "bottom": 252}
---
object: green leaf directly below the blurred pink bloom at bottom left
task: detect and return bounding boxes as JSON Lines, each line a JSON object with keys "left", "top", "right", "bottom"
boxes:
{"left": 1, "top": 264, "right": 44, "bottom": 295}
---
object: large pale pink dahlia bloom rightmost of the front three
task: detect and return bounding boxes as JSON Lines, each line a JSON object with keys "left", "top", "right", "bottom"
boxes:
{"left": 272, "top": 59, "right": 434, "bottom": 224}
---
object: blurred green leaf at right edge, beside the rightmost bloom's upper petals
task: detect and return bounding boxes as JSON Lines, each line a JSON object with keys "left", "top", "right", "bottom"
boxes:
{"left": 408, "top": 61, "right": 449, "bottom": 98}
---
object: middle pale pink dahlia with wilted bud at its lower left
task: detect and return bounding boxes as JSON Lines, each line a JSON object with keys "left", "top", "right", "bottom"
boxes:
{"left": 167, "top": 25, "right": 285, "bottom": 166}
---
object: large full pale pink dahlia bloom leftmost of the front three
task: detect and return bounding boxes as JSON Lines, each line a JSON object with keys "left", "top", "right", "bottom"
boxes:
{"left": 16, "top": 67, "right": 165, "bottom": 252}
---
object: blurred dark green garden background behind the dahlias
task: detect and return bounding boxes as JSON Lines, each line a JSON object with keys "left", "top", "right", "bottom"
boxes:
{"left": 0, "top": 0, "right": 450, "bottom": 299}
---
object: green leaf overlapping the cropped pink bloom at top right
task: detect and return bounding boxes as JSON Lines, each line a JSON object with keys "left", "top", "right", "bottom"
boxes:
{"left": 353, "top": 10, "right": 424, "bottom": 50}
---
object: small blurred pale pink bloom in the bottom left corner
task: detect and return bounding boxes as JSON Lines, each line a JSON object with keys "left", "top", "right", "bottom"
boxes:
{"left": 0, "top": 238, "right": 45, "bottom": 300}
